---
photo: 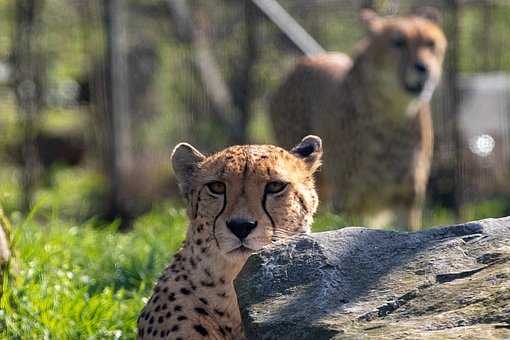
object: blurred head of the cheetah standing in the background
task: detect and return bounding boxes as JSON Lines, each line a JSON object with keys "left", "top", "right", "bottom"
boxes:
{"left": 362, "top": 10, "right": 446, "bottom": 100}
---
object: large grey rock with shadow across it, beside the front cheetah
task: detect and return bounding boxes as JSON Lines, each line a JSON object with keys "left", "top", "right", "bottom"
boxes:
{"left": 235, "top": 218, "right": 510, "bottom": 340}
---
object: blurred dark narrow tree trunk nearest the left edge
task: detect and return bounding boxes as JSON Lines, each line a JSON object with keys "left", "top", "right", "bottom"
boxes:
{"left": 12, "top": 0, "right": 46, "bottom": 212}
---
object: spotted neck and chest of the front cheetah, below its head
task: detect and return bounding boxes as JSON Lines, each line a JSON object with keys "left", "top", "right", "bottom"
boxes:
{"left": 138, "top": 224, "right": 245, "bottom": 340}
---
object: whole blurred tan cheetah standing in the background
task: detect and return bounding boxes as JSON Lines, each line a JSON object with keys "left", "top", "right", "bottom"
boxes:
{"left": 271, "top": 12, "right": 446, "bottom": 228}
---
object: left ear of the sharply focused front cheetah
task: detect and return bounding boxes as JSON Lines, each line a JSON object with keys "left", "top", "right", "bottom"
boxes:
{"left": 172, "top": 143, "right": 205, "bottom": 195}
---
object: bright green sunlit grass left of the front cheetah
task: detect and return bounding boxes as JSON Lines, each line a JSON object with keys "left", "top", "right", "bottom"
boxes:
{"left": 0, "top": 206, "right": 186, "bottom": 339}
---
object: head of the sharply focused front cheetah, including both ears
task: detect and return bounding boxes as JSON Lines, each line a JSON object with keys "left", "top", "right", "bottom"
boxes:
{"left": 172, "top": 136, "right": 322, "bottom": 261}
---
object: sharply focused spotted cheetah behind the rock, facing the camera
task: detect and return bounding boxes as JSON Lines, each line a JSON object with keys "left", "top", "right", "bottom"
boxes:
{"left": 138, "top": 136, "right": 322, "bottom": 339}
